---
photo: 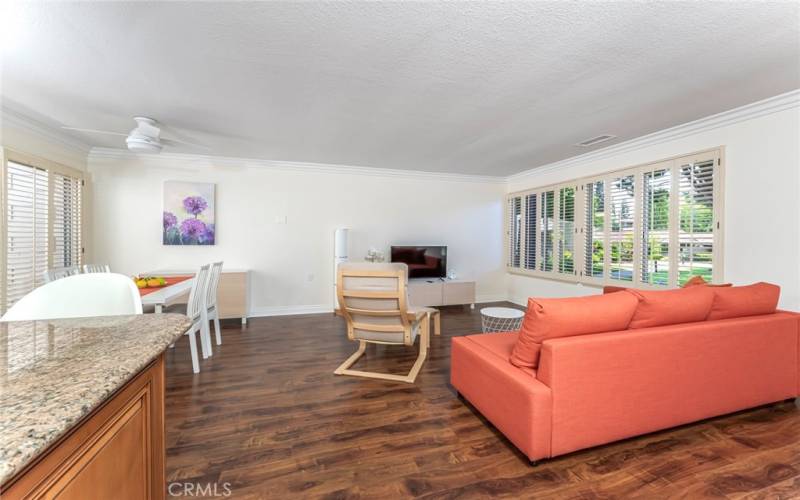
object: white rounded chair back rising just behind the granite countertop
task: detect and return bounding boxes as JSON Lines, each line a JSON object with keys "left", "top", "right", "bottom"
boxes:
{"left": 0, "top": 273, "right": 142, "bottom": 321}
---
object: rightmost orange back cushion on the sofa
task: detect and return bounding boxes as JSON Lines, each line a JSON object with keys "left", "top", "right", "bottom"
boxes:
{"left": 708, "top": 282, "right": 781, "bottom": 320}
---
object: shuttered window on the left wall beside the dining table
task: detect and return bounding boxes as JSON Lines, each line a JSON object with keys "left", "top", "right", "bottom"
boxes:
{"left": 0, "top": 150, "right": 83, "bottom": 311}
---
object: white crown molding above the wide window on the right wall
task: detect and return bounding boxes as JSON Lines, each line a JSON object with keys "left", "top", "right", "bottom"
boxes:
{"left": 505, "top": 89, "right": 800, "bottom": 183}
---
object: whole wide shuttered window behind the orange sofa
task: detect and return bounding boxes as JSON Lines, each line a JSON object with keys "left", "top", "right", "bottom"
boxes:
{"left": 508, "top": 149, "right": 722, "bottom": 288}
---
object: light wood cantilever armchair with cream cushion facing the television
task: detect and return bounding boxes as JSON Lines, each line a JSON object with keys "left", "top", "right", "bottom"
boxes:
{"left": 334, "top": 263, "right": 438, "bottom": 383}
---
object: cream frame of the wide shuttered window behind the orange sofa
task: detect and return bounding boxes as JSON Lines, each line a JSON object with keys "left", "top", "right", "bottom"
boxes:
{"left": 504, "top": 146, "right": 725, "bottom": 290}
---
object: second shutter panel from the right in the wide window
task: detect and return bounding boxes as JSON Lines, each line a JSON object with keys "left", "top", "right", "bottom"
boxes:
{"left": 641, "top": 166, "right": 672, "bottom": 286}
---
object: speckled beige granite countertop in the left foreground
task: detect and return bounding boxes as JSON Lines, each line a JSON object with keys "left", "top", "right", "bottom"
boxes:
{"left": 0, "top": 314, "right": 190, "bottom": 484}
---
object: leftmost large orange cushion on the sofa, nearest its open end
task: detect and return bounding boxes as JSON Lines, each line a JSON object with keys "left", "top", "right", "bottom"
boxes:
{"left": 510, "top": 293, "right": 637, "bottom": 368}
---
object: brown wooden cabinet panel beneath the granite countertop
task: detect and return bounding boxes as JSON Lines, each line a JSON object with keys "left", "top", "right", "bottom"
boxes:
{"left": 2, "top": 354, "right": 166, "bottom": 500}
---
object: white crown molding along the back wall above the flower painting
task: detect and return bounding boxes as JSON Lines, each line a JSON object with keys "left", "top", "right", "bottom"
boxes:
{"left": 89, "top": 148, "right": 506, "bottom": 184}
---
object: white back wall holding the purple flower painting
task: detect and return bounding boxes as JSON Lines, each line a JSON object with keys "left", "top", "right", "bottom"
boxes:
{"left": 89, "top": 152, "right": 506, "bottom": 315}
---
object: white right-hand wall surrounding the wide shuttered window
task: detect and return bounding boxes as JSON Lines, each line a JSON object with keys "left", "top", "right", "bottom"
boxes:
{"left": 508, "top": 93, "right": 800, "bottom": 310}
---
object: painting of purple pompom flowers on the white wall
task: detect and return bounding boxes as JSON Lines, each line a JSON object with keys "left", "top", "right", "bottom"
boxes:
{"left": 163, "top": 181, "right": 216, "bottom": 245}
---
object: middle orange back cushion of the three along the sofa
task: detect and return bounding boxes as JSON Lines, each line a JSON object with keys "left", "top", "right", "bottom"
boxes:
{"left": 615, "top": 286, "right": 714, "bottom": 328}
